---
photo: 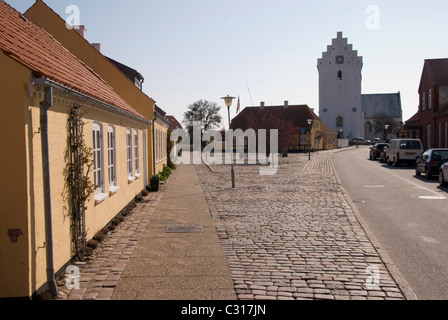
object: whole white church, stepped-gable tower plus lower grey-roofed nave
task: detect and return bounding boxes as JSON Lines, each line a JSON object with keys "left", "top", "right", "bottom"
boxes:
{"left": 317, "top": 32, "right": 403, "bottom": 140}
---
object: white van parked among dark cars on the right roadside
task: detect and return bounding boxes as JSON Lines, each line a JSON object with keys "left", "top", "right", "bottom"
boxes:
{"left": 386, "top": 139, "right": 423, "bottom": 166}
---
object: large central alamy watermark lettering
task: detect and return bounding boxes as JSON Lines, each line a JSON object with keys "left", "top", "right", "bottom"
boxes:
{"left": 170, "top": 122, "right": 279, "bottom": 176}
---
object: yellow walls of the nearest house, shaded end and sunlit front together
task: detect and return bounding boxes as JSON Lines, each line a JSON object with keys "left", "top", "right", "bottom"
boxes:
{"left": 0, "top": 51, "right": 150, "bottom": 298}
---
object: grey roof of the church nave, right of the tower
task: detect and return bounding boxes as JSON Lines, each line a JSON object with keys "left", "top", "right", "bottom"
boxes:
{"left": 362, "top": 92, "right": 403, "bottom": 119}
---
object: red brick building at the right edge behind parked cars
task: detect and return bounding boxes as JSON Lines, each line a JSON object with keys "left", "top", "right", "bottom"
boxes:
{"left": 405, "top": 59, "right": 448, "bottom": 149}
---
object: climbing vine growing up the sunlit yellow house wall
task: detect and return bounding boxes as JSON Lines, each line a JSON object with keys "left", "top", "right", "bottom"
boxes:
{"left": 67, "top": 107, "right": 95, "bottom": 260}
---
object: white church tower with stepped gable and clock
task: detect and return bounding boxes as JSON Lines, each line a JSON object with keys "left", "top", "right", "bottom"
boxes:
{"left": 317, "top": 32, "right": 364, "bottom": 139}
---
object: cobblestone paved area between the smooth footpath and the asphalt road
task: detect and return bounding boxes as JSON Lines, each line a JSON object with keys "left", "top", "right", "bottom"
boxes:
{"left": 196, "top": 152, "right": 414, "bottom": 300}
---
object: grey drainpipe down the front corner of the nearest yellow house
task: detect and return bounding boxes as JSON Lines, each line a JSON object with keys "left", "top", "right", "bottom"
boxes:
{"left": 40, "top": 87, "right": 58, "bottom": 298}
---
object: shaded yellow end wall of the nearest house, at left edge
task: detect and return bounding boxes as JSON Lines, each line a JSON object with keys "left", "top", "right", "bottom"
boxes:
{"left": 0, "top": 50, "right": 30, "bottom": 298}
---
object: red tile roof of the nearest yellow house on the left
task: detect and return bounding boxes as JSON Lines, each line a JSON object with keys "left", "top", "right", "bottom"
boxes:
{"left": 0, "top": 0, "right": 147, "bottom": 120}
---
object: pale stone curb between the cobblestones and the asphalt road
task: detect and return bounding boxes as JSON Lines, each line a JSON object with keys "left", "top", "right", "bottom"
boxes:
{"left": 331, "top": 150, "right": 419, "bottom": 300}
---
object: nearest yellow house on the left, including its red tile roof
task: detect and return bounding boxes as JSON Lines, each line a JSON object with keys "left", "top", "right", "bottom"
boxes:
{"left": 0, "top": 1, "right": 151, "bottom": 298}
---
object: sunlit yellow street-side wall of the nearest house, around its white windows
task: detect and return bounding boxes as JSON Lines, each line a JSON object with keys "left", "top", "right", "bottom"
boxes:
{"left": 25, "top": 92, "right": 146, "bottom": 293}
